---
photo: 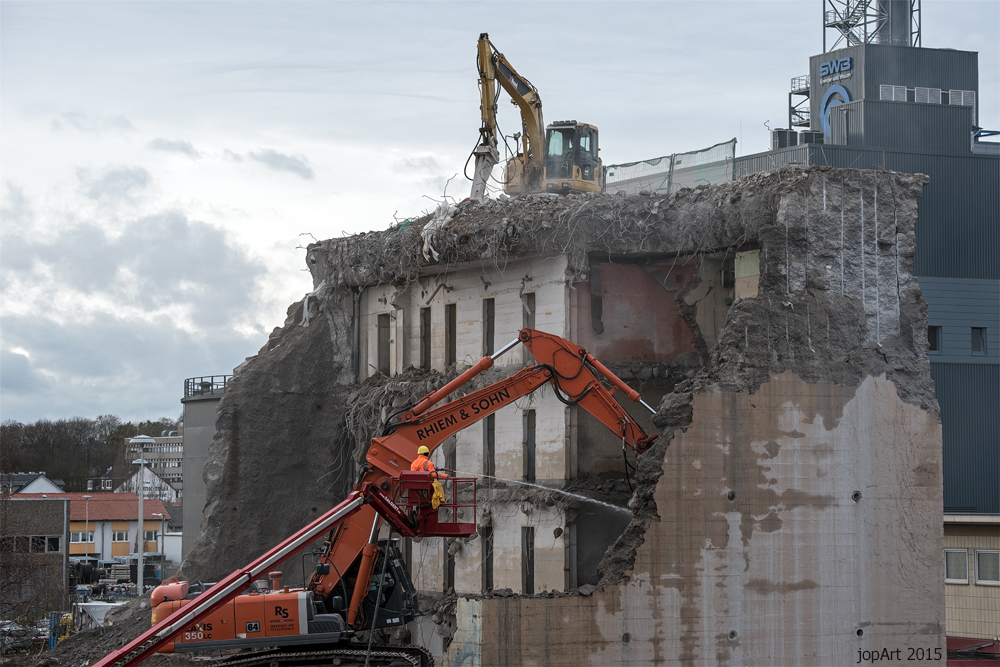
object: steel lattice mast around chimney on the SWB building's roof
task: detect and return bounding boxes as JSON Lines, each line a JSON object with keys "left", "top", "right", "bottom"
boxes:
{"left": 823, "top": 0, "right": 921, "bottom": 53}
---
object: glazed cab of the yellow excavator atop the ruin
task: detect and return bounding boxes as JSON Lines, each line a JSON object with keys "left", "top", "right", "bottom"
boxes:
{"left": 545, "top": 120, "right": 604, "bottom": 192}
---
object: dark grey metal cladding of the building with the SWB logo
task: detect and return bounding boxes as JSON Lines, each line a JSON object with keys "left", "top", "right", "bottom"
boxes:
{"left": 735, "top": 44, "right": 1000, "bottom": 514}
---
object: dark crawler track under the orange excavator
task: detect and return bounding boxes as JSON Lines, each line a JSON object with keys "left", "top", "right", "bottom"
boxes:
{"left": 214, "top": 642, "right": 434, "bottom": 667}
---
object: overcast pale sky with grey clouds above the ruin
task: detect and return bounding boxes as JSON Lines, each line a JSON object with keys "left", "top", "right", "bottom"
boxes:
{"left": 0, "top": 0, "right": 1000, "bottom": 421}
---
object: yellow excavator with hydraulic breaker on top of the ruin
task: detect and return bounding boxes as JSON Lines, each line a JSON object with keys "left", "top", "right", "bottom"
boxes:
{"left": 470, "top": 32, "right": 604, "bottom": 202}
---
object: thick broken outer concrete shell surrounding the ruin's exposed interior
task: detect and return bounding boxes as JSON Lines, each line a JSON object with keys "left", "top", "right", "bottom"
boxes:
{"left": 185, "top": 168, "right": 944, "bottom": 665}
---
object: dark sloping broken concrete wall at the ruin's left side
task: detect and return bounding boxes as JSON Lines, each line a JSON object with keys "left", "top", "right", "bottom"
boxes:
{"left": 181, "top": 290, "right": 356, "bottom": 585}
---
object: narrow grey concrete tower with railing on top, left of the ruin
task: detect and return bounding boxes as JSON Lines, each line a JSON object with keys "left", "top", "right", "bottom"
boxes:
{"left": 181, "top": 375, "right": 229, "bottom": 555}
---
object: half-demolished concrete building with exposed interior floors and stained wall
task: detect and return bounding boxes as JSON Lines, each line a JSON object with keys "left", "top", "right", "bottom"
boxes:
{"left": 254, "top": 163, "right": 945, "bottom": 665}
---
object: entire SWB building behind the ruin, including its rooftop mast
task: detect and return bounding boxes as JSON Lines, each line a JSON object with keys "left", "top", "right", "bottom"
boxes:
{"left": 736, "top": 0, "right": 1000, "bottom": 639}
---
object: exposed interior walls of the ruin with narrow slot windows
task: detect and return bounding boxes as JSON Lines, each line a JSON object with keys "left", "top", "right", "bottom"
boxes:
{"left": 359, "top": 256, "right": 704, "bottom": 594}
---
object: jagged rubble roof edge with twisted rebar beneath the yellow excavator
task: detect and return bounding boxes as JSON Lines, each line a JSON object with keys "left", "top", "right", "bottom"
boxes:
{"left": 306, "top": 167, "right": 826, "bottom": 288}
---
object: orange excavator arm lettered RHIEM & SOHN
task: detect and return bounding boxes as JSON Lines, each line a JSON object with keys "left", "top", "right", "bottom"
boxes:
{"left": 309, "top": 329, "right": 655, "bottom": 616}
